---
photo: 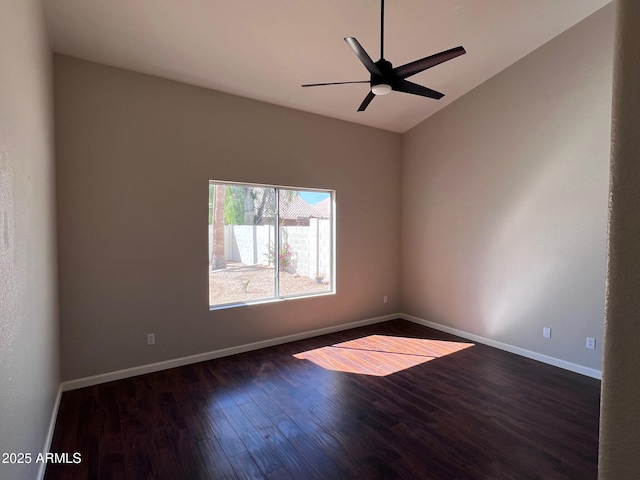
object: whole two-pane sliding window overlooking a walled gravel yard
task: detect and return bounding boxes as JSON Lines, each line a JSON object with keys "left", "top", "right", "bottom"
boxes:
{"left": 209, "top": 181, "right": 335, "bottom": 308}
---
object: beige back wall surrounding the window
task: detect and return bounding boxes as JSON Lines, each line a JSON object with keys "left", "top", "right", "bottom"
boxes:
{"left": 54, "top": 56, "right": 402, "bottom": 380}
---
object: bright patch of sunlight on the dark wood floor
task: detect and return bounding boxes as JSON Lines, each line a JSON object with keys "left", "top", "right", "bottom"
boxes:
{"left": 294, "top": 335, "right": 474, "bottom": 377}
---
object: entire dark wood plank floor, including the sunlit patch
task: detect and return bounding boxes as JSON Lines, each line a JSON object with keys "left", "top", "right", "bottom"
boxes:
{"left": 45, "top": 320, "right": 600, "bottom": 480}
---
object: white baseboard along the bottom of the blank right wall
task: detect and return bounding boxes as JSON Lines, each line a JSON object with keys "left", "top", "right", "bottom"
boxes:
{"left": 397, "top": 313, "right": 602, "bottom": 380}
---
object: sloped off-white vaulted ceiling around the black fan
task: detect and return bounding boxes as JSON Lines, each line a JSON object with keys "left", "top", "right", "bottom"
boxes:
{"left": 43, "top": 0, "right": 610, "bottom": 132}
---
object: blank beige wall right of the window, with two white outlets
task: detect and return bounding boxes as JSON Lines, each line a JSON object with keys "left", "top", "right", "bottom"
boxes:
{"left": 401, "top": 5, "right": 614, "bottom": 370}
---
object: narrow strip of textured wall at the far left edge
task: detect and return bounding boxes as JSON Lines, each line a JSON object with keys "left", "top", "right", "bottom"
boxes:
{"left": 0, "top": 0, "right": 60, "bottom": 480}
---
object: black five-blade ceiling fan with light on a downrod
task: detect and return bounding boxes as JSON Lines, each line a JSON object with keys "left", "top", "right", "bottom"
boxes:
{"left": 302, "top": 0, "right": 467, "bottom": 112}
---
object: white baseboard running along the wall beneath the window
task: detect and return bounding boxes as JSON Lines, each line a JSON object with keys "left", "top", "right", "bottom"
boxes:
{"left": 61, "top": 314, "right": 399, "bottom": 392}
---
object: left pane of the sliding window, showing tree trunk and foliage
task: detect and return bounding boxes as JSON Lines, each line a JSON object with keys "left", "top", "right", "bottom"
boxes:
{"left": 209, "top": 182, "right": 276, "bottom": 306}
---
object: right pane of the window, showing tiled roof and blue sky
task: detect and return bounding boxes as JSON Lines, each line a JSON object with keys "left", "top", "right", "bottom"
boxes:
{"left": 278, "top": 189, "right": 333, "bottom": 296}
